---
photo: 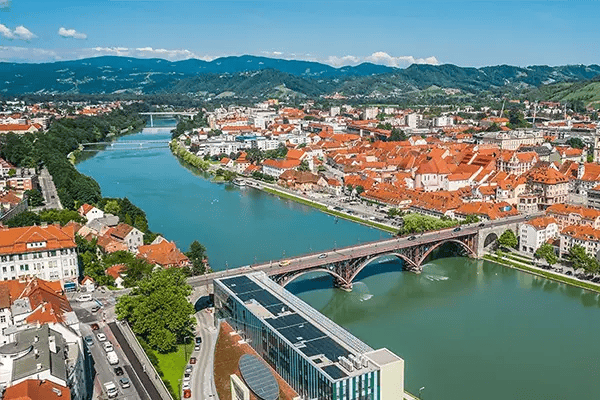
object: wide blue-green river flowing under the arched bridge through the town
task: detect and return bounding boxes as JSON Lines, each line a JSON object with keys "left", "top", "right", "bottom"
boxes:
{"left": 77, "top": 123, "right": 600, "bottom": 400}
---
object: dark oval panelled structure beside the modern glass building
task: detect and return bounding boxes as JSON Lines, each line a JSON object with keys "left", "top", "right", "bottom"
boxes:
{"left": 239, "top": 354, "right": 279, "bottom": 400}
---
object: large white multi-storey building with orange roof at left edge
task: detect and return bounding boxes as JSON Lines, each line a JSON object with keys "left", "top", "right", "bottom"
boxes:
{"left": 0, "top": 225, "right": 79, "bottom": 282}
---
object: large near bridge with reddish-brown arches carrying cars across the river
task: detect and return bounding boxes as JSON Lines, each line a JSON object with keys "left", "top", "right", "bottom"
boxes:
{"left": 188, "top": 216, "right": 527, "bottom": 290}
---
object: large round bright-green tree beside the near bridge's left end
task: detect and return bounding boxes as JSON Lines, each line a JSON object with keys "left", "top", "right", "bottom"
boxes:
{"left": 116, "top": 268, "right": 194, "bottom": 353}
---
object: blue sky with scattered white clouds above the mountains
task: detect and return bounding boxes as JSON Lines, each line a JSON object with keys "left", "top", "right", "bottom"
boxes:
{"left": 0, "top": 0, "right": 600, "bottom": 67}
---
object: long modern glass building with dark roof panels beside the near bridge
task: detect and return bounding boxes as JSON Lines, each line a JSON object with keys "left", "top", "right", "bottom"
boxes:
{"left": 214, "top": 272, "right": 404, "bottom": 400}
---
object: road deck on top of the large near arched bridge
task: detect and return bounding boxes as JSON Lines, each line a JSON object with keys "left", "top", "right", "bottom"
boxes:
{"left": 188, "top": 214, "right": 537, "bottom": 287}
